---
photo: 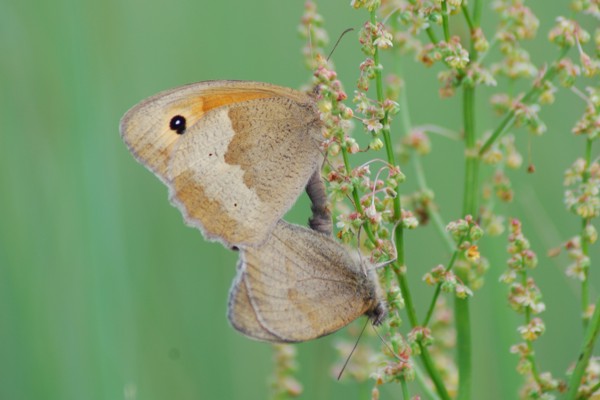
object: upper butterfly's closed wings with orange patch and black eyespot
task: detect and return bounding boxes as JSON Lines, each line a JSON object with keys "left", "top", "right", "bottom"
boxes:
{"left": 121, "top": 81, "right": 323, "bottom": 246}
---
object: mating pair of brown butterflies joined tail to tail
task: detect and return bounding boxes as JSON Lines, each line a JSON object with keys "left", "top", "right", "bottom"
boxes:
{"left": 120, "top": 81, "right": 386, "bottom": 342}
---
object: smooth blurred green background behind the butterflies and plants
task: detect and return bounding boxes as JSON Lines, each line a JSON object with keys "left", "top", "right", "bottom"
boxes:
{"left": 0, "top": 0, "right": 600, "bottom": 400}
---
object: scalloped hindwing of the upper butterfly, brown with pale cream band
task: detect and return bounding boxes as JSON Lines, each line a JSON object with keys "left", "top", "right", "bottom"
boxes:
{"left": 168, "top": 97, "right": 323, "bottom": 246}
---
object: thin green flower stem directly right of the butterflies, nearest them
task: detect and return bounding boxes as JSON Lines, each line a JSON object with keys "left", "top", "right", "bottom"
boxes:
{"left": 370, "top": 10, "right": 450, "bottom": 400}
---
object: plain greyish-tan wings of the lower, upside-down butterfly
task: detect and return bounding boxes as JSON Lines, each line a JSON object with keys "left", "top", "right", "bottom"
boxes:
{"left": 229, "top": 221, "right": 379, "bottom": 342}
